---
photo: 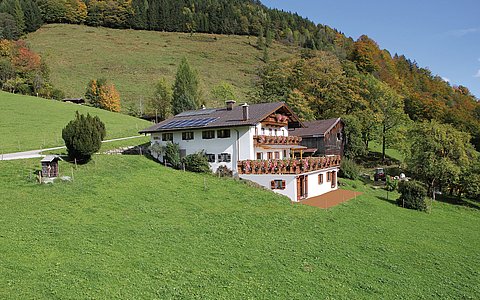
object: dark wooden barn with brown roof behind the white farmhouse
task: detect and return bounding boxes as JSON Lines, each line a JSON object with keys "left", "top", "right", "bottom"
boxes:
{"left": 289, "top": 118, "right": 345, "bottom": 156}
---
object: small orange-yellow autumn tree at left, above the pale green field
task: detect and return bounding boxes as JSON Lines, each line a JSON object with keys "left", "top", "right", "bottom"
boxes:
{"left": 85, "top": 78, "right": 120, "bottom": 112}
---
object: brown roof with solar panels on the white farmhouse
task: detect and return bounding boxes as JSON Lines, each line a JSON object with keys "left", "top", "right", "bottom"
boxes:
{"left": 140, "top": 102, "right": 302, "bottom": 133}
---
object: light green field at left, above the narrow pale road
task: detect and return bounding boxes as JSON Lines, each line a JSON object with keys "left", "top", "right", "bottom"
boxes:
{"left": 0, "top": 91, "right": 151, "bottom": 153}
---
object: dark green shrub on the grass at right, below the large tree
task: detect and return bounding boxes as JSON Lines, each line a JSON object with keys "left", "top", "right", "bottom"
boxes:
{"left": 397, "top": 181, "right": 428, "bottom": 211}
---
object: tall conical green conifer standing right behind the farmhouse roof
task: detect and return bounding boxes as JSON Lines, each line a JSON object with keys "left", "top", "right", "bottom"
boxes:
{"left": 172, "top": 57, "right": 200, "bottom": 115}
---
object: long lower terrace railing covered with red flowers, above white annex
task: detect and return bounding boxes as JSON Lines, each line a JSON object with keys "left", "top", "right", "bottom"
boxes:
{"left": 238, "top": 155, "right": 341, "bottom": 174}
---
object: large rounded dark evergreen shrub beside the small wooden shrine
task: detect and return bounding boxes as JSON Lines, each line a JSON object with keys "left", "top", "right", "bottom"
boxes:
{"left": 62, "top": 111, "right": 106, "bottom": 162}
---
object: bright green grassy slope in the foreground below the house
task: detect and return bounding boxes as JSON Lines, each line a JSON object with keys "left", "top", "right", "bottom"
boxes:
{"left": 0, "top": 156, "right": 480, "bottom": 299}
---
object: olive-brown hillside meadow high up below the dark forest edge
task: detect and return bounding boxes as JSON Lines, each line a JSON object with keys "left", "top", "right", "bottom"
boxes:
{"left": 27, "top": 24, "right": 294, "bottom": 105}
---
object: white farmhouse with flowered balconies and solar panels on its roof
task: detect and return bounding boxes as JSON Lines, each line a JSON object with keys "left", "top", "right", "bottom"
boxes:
{"left": 140, "top": 101, "right": 340, "bottom": 201}
